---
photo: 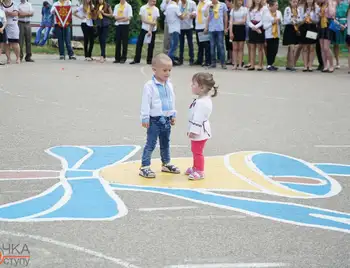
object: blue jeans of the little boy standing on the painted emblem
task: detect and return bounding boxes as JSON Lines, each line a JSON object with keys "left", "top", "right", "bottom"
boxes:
{"left": 142, "top": 116, "right": 171, "bottom": 167}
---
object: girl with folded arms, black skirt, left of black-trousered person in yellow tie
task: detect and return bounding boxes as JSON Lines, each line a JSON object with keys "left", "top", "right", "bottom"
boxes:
{"left": 247, "top": 0, "right": 265, "bottom": 71}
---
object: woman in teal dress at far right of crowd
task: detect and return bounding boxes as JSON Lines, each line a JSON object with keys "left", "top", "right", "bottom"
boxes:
{"left": 332, "top": 0, "right": 349, "bottom": 69}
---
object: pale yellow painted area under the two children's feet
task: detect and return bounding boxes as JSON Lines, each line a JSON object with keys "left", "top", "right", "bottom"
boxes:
{"left": 100, "top": 156, "right": 260, "bottom": 191}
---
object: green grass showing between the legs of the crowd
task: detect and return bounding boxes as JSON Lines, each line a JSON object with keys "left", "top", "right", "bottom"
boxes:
{"left": 32, "top": 34, "right": 348, "bottom": 67}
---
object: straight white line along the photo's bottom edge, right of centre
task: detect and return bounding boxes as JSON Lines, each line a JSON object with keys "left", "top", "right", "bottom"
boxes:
{"left": 166, "top": 262, "right": 289, "bottom": 268}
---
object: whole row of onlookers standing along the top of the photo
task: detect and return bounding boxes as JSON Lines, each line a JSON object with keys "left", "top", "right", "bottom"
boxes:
{"left": 0, "top": 0, "right": 350, "bottom": 73}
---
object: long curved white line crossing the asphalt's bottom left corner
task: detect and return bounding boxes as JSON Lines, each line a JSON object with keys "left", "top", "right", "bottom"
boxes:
{"left": 0, "top": 230, "right": 140, "bottom": 268}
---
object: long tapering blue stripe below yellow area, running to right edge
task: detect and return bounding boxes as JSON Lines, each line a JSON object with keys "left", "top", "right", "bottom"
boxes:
{"left": 112, "top": 184, "right": 350, "bottom": 232}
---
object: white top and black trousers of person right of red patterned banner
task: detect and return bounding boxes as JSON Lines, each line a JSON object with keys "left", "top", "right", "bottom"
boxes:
{"left": 77, "top": 5, "right": 95, "bottom": 58}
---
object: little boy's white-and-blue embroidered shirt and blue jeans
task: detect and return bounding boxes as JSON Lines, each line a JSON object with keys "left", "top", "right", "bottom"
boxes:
{"left": 141, "top": 76, "right": 176, "bottom": 167}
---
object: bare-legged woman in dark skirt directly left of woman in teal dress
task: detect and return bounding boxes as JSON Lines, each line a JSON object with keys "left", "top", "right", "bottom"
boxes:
{"left": 319, "top": 0, "right": 337, "bottom": 73}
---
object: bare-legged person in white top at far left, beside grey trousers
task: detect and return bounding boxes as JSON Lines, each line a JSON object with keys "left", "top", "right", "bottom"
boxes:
{"left": 2, "top": 0, "right": 21, "bottom": 64}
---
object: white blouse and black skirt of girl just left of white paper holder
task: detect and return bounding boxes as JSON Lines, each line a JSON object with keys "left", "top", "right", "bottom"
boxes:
{"left": 283, "top": 7, "right": 301, "bottom": 46}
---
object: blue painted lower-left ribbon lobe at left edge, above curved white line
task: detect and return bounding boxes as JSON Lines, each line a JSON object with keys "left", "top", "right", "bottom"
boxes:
{"left": 0, "top": 186, "right": 64, "bottom": 219}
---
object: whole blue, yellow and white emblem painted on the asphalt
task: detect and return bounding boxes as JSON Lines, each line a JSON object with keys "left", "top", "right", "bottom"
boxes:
{"left": 0, "top": 145, "right": 350, "bottom": 233}
